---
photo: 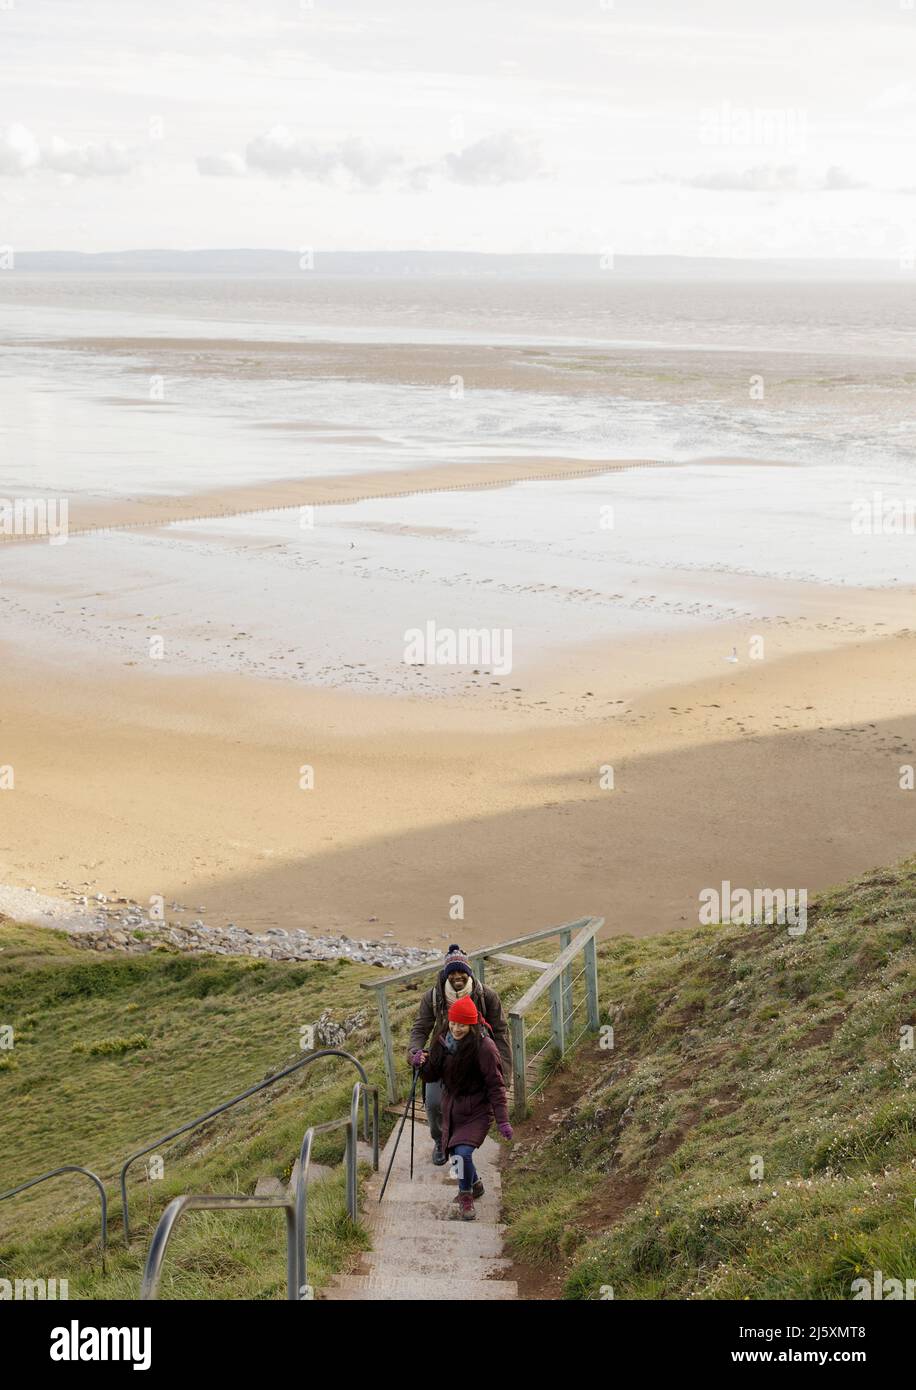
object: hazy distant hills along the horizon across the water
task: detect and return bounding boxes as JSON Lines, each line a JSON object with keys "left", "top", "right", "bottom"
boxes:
{"left": 13, "top": 247, "right": 910, "bottom": 281}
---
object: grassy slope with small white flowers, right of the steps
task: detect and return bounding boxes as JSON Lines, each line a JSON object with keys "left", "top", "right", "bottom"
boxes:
{"left": 503, "top": 860, "right": 916, "bottom": 1300}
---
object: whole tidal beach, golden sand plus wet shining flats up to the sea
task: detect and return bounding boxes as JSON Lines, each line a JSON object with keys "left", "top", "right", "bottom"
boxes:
{"left": 0, "top": 281, "right": 916, "bottom": 947}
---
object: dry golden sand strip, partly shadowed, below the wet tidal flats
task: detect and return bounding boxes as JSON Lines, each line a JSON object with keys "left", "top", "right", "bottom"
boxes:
{"left": 0, "top": 581, "right": 916, "bottom": 944}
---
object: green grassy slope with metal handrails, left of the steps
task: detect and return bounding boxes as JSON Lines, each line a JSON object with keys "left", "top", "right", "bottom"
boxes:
{"left": 0, "top": 923, "right": 411, "bottom": 1298}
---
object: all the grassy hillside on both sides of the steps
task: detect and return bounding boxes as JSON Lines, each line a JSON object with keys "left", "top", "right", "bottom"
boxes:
{"left": 0, "top": 860, "right": 916, "bottom": 1300}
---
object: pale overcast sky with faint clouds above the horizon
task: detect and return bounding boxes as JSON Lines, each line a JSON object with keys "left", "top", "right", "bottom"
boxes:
{"left": 0, "top": 0, "right": 916, "bottom": 260}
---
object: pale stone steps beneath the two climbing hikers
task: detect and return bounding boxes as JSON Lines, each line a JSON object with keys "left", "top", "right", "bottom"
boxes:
{"left": 321, "top": 1120, "right": 518, "bottom": 1301}
